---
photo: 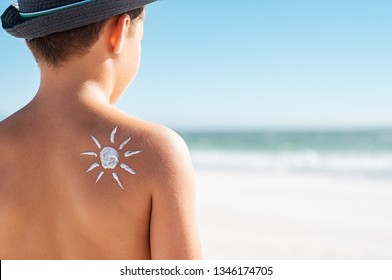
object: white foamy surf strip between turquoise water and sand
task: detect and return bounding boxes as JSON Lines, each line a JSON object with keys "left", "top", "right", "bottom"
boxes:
{"left": 191, "top": 150, "right": 392, "bottom": 176}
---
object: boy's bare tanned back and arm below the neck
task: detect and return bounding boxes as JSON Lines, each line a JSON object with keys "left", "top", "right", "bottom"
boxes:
{"left": 0, "top": 97, "right": 199, "bottom": 259}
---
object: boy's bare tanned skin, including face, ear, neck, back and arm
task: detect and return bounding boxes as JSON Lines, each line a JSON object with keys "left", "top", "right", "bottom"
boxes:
{"left": 0, "top": 11, "right": 201, "bottom": 259}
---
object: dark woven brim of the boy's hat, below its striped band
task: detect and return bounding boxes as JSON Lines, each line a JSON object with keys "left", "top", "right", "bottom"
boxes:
{"left": 1, "top": 0, "right": 157, "bottom": 40}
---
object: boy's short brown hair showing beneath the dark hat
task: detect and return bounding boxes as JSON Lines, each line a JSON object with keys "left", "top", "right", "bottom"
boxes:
{"left": 26, "top": 8, "right": 144, "bottom": 67}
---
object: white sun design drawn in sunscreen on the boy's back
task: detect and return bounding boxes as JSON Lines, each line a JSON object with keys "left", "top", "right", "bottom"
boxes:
{"left": 81, "top": 127, "right": 143, "bottom": 189}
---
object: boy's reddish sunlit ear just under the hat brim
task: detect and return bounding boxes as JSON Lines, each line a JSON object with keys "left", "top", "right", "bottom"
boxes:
{"left": 110, "top": 14, "right": 131, "bottom": 55}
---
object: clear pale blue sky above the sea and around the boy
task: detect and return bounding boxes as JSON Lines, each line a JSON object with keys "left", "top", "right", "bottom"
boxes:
{"left": 0, "top": 0, "right": 392, "bottom": 129}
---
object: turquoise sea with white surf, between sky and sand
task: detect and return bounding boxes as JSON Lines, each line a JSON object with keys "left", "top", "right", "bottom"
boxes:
{"left": 180, "top": 129, "right": 392, "bottom": 178}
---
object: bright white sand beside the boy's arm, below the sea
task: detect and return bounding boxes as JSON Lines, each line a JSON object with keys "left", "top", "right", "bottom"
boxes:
{"left": 195, "top": 168, "right": 392, "bottom": 260}
